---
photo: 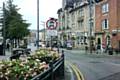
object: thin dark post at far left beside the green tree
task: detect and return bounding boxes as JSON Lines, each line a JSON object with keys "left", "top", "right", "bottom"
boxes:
{"left": 3, "top": 2, "right": 6, "bottom": 55}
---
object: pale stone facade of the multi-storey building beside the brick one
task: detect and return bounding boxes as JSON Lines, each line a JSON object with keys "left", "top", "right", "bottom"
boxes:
{"left": 58, "top": 0, "right": 95, "bottom": 47}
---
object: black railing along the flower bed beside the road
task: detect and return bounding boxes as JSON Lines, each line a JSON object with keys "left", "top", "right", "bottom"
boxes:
{"left": 32, "top": 54, "right": 64, "bottom": 80}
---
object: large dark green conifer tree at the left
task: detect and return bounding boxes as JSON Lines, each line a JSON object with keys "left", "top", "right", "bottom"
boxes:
{"left": 4, "top": 0, "right": 30, "bottom": 45}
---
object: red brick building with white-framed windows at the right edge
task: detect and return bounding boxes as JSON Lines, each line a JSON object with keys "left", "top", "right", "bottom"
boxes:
{"left": 95, "top": 0, "right": 120, "bottom": 49}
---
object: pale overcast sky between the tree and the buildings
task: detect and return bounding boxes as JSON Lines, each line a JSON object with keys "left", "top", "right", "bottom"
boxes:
{"left": 0, "top": 0, "right": 62, "bottom": 29}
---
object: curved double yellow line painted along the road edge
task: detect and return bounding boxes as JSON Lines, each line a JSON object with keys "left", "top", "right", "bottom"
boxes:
{"left": 67, "top": 62, "right": 84, "bottom": 80}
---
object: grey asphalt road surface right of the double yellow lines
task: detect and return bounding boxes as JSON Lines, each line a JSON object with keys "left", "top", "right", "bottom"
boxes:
{"left": 64, "top": 50, "right": 120, "bottom": 80}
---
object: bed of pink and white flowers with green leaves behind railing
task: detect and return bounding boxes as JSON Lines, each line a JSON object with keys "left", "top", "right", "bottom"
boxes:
{"left": 0, "top": 49, "right": 61, "bottom": 80}
